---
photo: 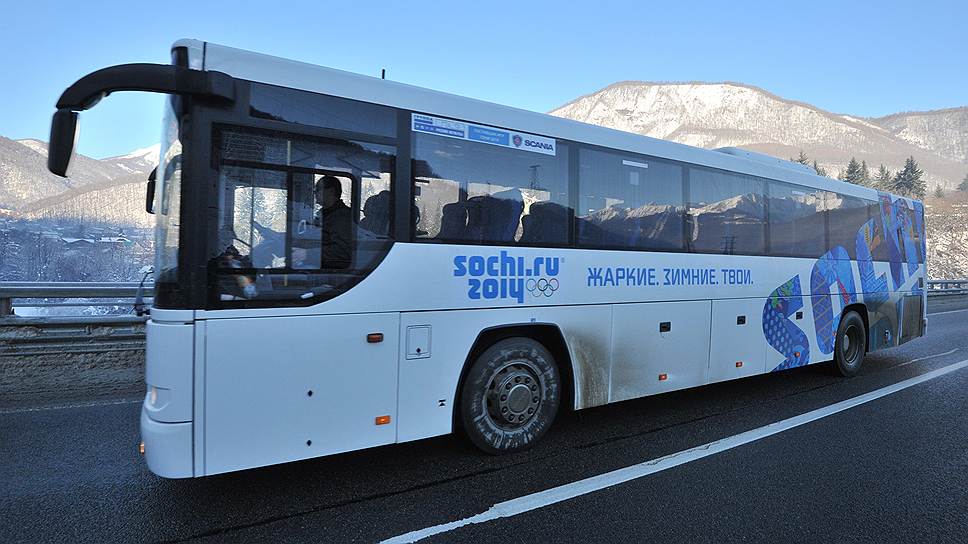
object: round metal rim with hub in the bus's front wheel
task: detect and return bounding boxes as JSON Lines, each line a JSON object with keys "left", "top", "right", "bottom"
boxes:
{"left": 484, "top": 360, "right": 543, "bottom": 430}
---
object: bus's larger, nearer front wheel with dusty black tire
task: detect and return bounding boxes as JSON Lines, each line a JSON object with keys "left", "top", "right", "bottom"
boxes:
{"left": 460, "top": 337, "right": 561, "bottom": 455}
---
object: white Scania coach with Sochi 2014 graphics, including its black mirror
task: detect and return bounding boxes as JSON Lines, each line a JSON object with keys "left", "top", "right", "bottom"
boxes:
{"left": 49, "top": 40, "right": 926, "bottom": 478}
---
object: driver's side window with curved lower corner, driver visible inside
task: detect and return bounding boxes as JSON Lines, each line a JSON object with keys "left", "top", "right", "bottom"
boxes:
{"left": 209, "top": 129, "right": 395, "bottom": 307}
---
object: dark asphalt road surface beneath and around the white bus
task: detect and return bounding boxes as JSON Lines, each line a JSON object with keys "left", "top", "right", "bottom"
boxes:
{"left": 0, "top": 297, "right": 968, "bottom": 543}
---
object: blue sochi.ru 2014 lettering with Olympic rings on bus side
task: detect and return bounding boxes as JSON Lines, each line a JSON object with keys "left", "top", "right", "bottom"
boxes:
{"left": 454, "top": 251, "right": 560, "bottom": 304}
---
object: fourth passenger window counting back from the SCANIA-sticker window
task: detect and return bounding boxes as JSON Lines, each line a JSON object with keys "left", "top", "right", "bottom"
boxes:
{"left": 768, "top": 181, "right": 827, "bottom": 259}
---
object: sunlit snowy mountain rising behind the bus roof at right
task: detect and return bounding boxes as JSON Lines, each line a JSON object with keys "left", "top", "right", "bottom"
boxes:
{"left": 551, "top": 81, "right": 968, "bottom": 188}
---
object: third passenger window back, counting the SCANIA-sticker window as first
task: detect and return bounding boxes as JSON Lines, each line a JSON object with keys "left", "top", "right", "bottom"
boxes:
{"left": 686, "top": 167, "right": 766, "bottom": 255}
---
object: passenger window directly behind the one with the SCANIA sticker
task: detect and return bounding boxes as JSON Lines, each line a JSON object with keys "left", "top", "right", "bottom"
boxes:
{"left": 576, "top": 149, "right": 685, "bottom": 251}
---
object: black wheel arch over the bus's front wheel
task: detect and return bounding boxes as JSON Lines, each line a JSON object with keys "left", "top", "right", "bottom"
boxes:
{"left": 452, "top": 322, "right": 575, "bottom": 431}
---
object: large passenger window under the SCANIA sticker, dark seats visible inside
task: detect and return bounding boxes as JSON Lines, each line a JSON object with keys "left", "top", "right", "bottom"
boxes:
{"left": 413, "top": 133, "right": 572, "bottom": 245}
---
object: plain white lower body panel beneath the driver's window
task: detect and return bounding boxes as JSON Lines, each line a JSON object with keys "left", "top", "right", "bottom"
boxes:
{"left": 203, "top": 313, "right": 400, "bottom": 474}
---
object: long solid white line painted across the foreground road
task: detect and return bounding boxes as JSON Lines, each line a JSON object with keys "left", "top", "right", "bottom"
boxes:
{"left": 383, "top": 359, "right": 968, "bottom": 544}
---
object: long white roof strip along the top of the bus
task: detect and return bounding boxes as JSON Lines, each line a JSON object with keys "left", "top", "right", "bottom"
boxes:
{"left": 172, "top": 39, "right": 916, "bottom": 204}
